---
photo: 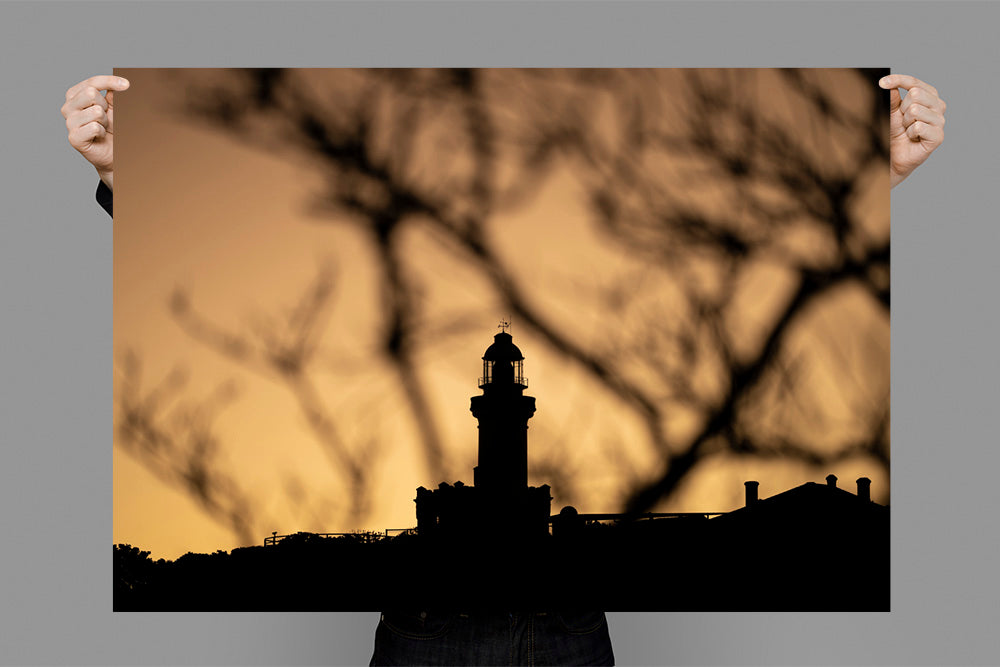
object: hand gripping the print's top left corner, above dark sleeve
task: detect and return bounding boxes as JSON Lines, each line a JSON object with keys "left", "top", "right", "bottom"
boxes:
{"left": 62, "top": 75, "right": 129, "bottom": 191}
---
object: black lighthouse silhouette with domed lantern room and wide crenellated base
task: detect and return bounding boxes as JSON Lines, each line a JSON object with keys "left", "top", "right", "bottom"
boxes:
{"left": 416, "top": 322, "right": 552, "bottom": 539}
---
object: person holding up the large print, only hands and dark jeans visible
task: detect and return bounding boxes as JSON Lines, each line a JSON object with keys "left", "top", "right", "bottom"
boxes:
{"left": 70, "top": 74, "right": 947, "bottom": 665}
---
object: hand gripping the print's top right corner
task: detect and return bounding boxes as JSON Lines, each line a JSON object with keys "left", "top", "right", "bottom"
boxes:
{"left": 878, "top": 74, "right": 948, "bottom": 187}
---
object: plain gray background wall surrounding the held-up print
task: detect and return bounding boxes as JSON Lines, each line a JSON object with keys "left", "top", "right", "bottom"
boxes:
{"left": 0, "top": 2, "right": 1000, "bottom": 665}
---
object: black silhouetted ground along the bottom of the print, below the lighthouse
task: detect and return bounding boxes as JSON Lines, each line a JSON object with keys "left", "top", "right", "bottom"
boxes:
{"left": 114, "top": 508, "right": 889, "bottom": 611}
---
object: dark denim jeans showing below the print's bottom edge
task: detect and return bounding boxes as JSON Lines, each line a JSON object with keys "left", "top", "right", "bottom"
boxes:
{"left": 370, "top": 611, "right": 615, "bottom": 666}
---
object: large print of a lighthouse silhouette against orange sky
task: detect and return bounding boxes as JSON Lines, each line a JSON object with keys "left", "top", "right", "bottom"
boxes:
{"left": 113, "top": 69, "right": 890, "bottom": 611}
